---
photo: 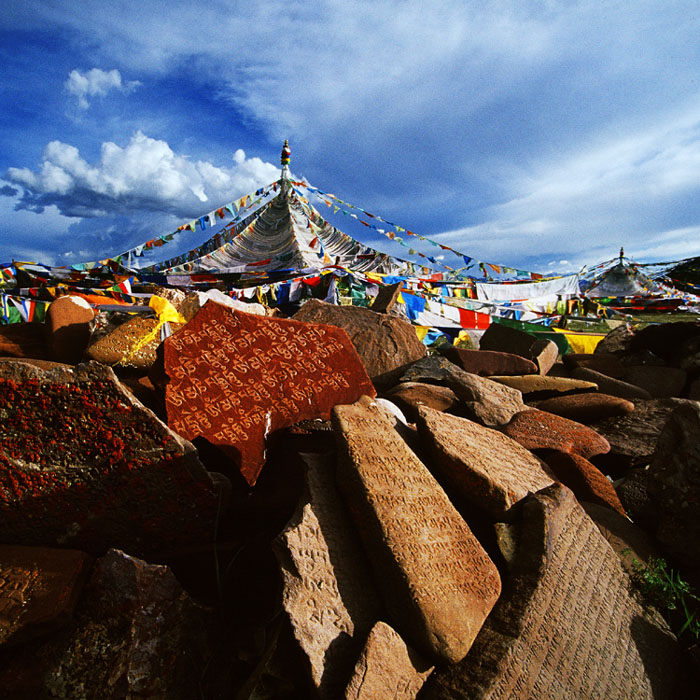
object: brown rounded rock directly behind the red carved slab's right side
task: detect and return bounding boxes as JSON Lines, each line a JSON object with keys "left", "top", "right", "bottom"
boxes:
{"left": 293, "top": 299, "right": 426, "bottom": 384}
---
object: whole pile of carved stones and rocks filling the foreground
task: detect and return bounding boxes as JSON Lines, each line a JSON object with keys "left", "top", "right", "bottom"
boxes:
{"left": 0, "top": 302, "right": 700, "bottom": 700}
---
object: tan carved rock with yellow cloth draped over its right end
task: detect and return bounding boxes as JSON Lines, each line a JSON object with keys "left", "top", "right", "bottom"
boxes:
{"left": 85, "top": 316, "right": 180, "bottom": 370}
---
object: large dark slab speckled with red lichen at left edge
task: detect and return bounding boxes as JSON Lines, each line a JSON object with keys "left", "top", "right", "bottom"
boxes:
{"left": 0, "top": 361, "right": 218, "bottom": 554}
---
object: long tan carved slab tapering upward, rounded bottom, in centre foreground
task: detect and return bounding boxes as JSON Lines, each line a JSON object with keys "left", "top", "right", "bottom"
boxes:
{"left": 332, "top": 397, "right": 501, "bottom": 663}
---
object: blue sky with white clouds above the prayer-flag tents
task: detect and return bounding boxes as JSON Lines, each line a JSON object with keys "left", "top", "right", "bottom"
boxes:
{"left": 0, "top": 0, "right": 700, "bottom": 272}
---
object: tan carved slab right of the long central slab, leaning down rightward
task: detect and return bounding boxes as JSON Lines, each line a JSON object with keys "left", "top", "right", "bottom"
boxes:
{"left": 418, "top": 407, "right": 556, "bottom": 518}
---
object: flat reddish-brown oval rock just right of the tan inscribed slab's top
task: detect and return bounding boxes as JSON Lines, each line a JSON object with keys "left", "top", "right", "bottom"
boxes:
{"left": 501, "top": 410, "right": 610, "bottom": 459}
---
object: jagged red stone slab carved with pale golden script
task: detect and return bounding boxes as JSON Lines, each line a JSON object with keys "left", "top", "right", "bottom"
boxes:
{"left": 163, "top": 301, "right": 374, "bottom": 486}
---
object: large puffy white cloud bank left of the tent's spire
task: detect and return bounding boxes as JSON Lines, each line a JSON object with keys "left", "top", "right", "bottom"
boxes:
{"left": 5, "top": 131, "right": 279, "bottom": 217}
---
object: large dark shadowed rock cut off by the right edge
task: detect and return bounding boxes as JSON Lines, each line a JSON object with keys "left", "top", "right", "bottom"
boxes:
{"left": 647, "top": 401, "right": 700, "bottom": 570}
